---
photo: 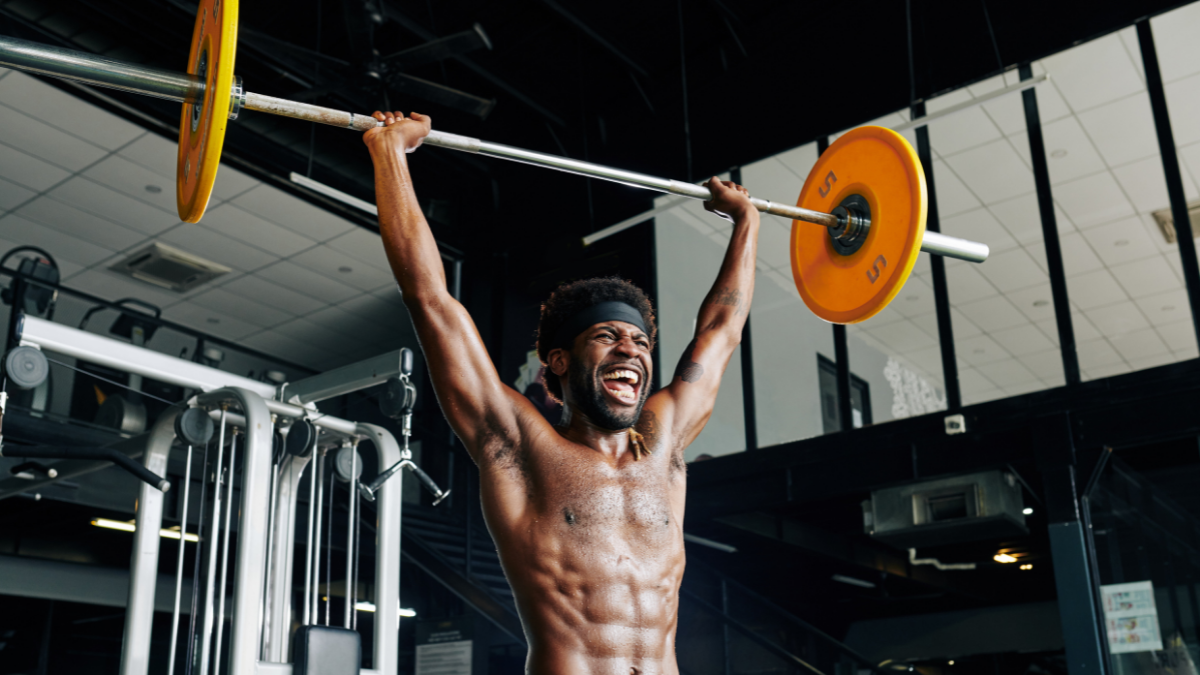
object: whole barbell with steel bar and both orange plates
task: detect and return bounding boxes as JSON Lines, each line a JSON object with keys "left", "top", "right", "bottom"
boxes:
{"left": 0, "top": 0, "right": 989, "bottom": 323}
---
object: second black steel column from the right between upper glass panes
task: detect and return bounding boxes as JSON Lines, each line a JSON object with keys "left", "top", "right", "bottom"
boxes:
{"left": 1021, "top": 65, "right": 1080, "bottom": 387}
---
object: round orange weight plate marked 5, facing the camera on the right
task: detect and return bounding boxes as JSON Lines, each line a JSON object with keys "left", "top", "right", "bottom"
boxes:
{"left": 792, "top": 126, "right": 928, "bottom": 323}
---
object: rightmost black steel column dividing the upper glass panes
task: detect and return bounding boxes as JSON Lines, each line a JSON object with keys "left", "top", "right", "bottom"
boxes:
{"left": 1138, "top": 19, "right": 1200, "bottom": 339}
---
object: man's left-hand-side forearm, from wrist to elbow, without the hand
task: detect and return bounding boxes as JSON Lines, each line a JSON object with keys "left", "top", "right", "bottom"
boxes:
{"left": 371, "top": 144, "right": 446, "bottom": 299}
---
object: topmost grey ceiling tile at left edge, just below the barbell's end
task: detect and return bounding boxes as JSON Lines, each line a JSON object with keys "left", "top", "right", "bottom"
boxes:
{"left": 0, "top": 72, "right": 145, "bottom": 150}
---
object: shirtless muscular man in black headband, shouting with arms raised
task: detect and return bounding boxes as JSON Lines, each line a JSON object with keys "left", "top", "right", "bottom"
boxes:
{"left": 364, "top": 112, "right": 758, "bottom": 675}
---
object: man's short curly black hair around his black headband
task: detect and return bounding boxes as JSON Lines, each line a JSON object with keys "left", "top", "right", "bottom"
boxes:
{"left": 538, "top": 276, "right": 659, "bottom": 402}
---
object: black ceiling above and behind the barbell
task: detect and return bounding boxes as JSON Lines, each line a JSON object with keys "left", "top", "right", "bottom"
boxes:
{"left": 0, "top": 0, "right": 1181, "bottom": 261}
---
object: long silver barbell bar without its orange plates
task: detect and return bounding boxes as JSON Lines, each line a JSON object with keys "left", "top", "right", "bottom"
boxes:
{"left": 0, "top": 36, "right": 989, "bottom": 263}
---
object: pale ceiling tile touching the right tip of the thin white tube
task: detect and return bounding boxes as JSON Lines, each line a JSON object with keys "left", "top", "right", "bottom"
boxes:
{"left": 1042, "top": 35, "right": 1144, "bottom": 112}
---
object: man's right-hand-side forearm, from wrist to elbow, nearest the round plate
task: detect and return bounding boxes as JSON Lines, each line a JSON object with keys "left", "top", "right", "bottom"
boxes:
{"left": 696, "top": 211, "right": 758, "bottom": 335}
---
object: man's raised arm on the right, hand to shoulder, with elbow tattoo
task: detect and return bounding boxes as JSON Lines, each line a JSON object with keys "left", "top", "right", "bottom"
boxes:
{"left": 647, "top": 177, "right": 758, "bottom": 448}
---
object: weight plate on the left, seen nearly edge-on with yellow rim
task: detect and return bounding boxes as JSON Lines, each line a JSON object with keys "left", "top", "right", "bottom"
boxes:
{"left": 175, "top": 0, "right": 238, "bottom": 222}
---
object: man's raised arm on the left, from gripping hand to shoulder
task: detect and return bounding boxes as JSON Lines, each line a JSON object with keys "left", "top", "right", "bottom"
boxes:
{"left": 362, "top": 112, "right": 520, "bottom": 462}
